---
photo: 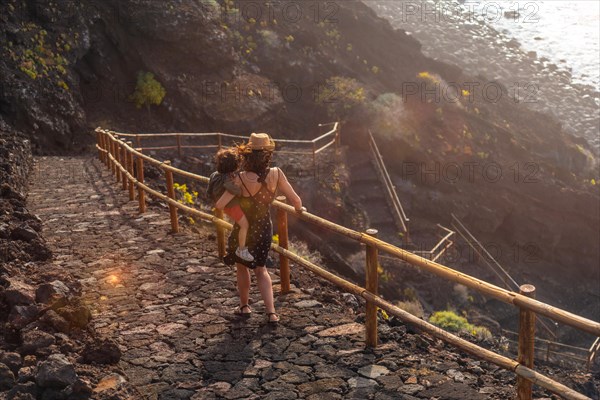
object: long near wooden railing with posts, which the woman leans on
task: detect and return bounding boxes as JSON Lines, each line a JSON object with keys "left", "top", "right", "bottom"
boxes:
{"left": 96, "top": 129, "right": 600, "bottom": 399}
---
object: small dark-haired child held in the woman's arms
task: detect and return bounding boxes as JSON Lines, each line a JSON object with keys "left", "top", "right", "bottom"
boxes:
{"left": 207, "top": 149, "right": 254, "bottom": 262}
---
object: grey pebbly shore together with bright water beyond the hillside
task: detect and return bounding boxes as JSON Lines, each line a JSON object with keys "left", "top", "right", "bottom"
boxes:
{"left": 363, "top": 0, "right": 600, "bottom": 147}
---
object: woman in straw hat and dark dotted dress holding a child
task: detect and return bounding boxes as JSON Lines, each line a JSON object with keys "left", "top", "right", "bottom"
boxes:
{"left": 216, "top": 133, "right": 303, "bottom": 323}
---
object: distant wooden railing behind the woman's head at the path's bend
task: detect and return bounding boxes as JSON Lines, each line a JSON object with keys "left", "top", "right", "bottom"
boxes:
{"left": 114, "top": 122, "right": 340, "bottom": 172}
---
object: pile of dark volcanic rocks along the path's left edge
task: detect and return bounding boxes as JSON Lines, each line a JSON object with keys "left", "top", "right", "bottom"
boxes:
{"left": 0, "top": 130, "right": 141, "bottom": 400}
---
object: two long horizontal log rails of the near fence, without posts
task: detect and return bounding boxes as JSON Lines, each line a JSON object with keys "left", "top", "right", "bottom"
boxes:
{"left": 97, "top": 131, "right": 600, "bottom": 400}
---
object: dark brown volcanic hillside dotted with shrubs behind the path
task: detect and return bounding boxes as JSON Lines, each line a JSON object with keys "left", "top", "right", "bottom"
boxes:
{"left": 0, "top": 0, "right": 600, "bottom": 332}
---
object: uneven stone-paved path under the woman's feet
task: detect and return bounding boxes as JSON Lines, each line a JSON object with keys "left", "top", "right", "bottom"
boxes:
{"left": 28, "top": 157, "right": 510, "bottom": 400}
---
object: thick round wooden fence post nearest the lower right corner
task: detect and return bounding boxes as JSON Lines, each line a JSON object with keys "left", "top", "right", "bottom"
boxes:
{"left": 517, "top": 285, "right": 535, "bottom": 400}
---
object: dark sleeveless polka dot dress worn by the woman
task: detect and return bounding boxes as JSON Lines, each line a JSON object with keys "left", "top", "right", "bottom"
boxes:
{"left": 224, "top": 169, "right": 275, "bottom": 269}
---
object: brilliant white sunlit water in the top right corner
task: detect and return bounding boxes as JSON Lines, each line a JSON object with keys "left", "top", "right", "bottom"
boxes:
{"left": 478, "top": 0, "right": 600, "bottom": 90}
